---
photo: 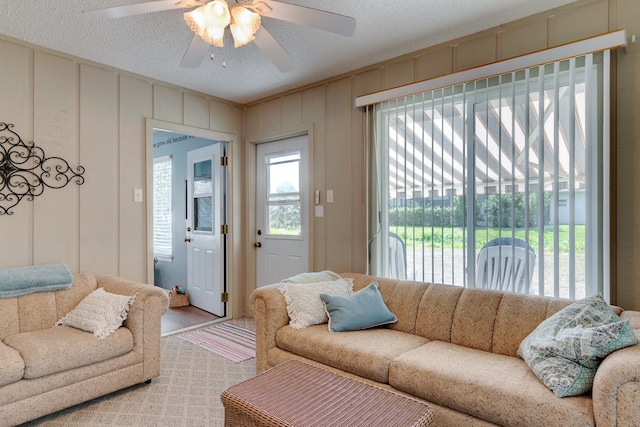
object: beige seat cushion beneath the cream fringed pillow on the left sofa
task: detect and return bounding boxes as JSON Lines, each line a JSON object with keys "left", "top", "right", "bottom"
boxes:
{"left": 4, "top": 326, "right": 133, "bottom": 378}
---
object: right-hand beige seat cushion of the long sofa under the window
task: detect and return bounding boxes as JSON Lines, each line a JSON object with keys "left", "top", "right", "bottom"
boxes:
{"left": 389, "top": 341, "right": 594, "bottom": 427}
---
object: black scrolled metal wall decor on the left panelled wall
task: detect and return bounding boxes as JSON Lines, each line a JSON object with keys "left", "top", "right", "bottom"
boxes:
{"left": 0, "top": 122, "right": 84, "bottom": 215}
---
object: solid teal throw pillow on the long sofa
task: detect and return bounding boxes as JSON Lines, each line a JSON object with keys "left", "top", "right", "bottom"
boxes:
{"left": 320, "top": 282, "right": 398, "bottom": 332}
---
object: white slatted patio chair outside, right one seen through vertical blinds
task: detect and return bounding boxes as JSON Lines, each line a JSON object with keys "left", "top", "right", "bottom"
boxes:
{"left": 476, "top": 237, "right": 536, "bottom": 293}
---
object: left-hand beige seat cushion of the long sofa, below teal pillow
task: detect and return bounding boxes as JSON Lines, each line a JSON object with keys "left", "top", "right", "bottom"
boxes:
{"left": 276, "top": 325, "right": 428, "bottom": 383}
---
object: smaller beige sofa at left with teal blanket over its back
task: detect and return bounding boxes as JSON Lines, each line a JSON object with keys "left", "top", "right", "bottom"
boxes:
{"left": 0, "top": 274, "right": 168, "bottom": 426}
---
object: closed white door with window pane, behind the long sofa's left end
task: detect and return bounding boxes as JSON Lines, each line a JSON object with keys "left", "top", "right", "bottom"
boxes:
{"left": 254, "top": 135, "right": 310, "bottom": 286}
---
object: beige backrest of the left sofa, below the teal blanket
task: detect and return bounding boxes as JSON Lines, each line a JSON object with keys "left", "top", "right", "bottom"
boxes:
{"left": 0, "top": 273, "right": 97, "bottom": 339}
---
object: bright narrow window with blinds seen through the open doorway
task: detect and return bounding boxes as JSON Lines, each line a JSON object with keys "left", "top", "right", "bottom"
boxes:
{"left": 153, "top": 156, "right": 173, "bottom": 261}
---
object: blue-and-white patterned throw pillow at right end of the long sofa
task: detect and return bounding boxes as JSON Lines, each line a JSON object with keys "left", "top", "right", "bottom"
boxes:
{"left": 518, "top": 294, "right": 638, "bottom": 397}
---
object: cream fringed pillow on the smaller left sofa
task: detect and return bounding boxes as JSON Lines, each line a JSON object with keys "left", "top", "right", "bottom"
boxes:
{"left": 54, "top": 288, "right": 138, "bottom": 339}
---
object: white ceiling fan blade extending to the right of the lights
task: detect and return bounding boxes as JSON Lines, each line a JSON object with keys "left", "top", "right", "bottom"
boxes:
{"left": 254, "top": 0, "right": 356, "bottom": 37}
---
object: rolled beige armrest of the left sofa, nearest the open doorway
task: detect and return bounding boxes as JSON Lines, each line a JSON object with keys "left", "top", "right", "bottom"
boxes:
{"left": 96, "top": 276, "right": 169, "bottom": 379}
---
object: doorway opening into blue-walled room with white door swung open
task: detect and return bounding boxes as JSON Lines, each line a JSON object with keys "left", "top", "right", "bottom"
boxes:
{"left": 148, "top": 122, "right": 229, "bottom": 335}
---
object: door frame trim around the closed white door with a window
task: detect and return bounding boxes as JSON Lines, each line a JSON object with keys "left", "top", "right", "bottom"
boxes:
{"left": 245, "top": 124, "right": 315, "bottom": 295}
